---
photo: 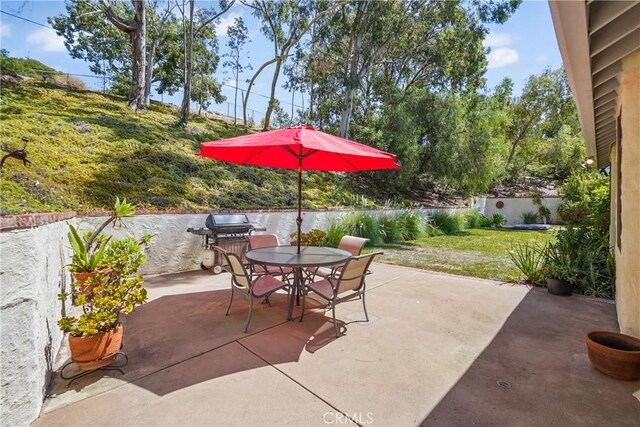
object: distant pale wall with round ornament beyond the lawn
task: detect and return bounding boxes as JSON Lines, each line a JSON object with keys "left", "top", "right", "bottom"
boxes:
{"left": 471, "top": 197, "right": 562, "bottom": 224}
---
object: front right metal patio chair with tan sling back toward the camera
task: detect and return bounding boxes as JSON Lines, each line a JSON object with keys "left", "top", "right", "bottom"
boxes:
{"left": 300, "top": 251, "right": 382, "bottom": 337}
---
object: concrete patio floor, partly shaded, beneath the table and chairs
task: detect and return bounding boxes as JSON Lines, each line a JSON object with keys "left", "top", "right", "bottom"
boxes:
{"left": 34, "top": 264, "right": 640, "bottom": 426}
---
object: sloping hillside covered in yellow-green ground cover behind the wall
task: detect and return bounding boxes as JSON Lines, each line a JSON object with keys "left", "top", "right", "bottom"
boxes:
{"left": 0, "top": 81, "right": 359, "bottom": 213}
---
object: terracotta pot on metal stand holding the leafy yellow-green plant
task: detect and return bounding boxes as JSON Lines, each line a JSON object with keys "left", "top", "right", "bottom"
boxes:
{"left": 69, "top": 325, "right": 124, "bottom": 370}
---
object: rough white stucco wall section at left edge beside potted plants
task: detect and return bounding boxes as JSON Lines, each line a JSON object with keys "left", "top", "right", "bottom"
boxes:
{"left": 0, "top": 220, "right": 74, "bottom": 426}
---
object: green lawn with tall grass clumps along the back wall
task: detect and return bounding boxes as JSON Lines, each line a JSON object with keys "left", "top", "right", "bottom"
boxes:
{"left": 316, "top": 210, "right": 553, "bottom": 282}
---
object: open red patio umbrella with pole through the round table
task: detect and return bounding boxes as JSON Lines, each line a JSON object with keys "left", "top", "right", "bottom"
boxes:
{"left": 197, "top": 125, "right": 400, "bottom": 252}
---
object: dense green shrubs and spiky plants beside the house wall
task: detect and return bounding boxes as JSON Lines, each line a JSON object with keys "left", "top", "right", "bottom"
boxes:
{"left": 509, "top": 170, "right": 615, "bottom": 298}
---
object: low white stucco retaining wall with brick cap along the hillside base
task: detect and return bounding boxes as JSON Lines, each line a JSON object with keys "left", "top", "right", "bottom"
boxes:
{"left": 0, "top": 209, "right": 464, "bottom": 425}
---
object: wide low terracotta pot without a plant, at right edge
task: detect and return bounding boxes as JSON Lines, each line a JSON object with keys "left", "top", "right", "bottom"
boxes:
{"left": 584, "top": 331, "right": 640, "bottom": 381}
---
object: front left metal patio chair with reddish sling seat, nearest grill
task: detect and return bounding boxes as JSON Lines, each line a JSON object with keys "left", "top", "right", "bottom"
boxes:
{"left": 213, "top": 246, "right": 290, "bottom": 333}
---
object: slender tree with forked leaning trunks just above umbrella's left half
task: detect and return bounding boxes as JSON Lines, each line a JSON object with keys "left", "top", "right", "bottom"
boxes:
{"left": 241, "top": 0, "right": 352, "bottom": 130}
